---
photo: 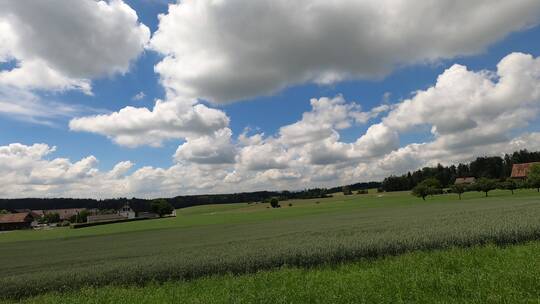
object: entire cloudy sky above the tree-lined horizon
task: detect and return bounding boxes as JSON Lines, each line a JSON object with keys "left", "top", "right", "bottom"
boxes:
{"left": 0, "top": 0, "right": 540, "bottom": 198}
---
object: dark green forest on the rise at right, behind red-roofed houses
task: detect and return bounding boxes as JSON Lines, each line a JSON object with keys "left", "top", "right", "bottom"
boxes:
{"left": 382, "top": 150, "right": 540, "bottom": 192}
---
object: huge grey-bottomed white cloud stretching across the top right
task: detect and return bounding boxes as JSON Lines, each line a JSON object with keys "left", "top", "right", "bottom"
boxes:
{"left": 150, "top": 0, "right": 540, "bottom": 103}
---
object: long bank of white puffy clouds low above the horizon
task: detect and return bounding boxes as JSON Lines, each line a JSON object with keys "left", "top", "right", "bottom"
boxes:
{"left": 4, "top": 53, "right": 540, "bottom": 197}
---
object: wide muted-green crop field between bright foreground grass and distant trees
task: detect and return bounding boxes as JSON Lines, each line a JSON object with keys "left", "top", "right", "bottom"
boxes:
{"left": 0, "top": 191, "right": 540, "bottom": 303}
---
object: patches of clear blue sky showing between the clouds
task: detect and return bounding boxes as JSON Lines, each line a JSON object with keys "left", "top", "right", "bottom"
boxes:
{"left": 0, "top": 0, "right": 540, "bottom": 195}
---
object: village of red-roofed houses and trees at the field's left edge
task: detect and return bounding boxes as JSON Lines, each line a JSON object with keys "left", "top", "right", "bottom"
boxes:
{"left": 0, "top": 200, "right": 176, "bottom": 231}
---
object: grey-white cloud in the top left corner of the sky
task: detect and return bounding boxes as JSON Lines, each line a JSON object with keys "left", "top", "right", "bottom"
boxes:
{"left": 0, "top": 0, "right": 150, "bottom": 94}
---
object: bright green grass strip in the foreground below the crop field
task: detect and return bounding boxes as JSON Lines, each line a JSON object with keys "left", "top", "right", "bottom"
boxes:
{"left": 5, "top": 242, "right": 540, "bottom": 304}
